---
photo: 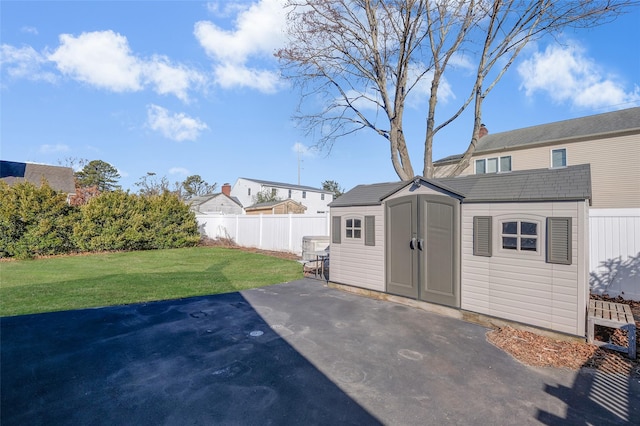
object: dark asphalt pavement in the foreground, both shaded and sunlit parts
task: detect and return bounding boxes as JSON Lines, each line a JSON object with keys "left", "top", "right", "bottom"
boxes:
{"left": 0, "top": 279, "right": 640, "bottom": 425}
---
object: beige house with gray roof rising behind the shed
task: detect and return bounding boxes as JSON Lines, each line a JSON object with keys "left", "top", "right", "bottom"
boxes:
{"left": 433, "top": 107, "right": 640, "bottom": 209}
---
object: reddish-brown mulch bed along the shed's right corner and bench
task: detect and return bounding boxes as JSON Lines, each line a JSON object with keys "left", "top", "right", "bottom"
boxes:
{"left": 487, "top": 295, "right": 640, "bottom": 377}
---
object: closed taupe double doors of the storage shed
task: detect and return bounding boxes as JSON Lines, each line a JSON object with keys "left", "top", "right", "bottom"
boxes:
{"left": 385, "top": 195, "right": 460, "bottom": 308}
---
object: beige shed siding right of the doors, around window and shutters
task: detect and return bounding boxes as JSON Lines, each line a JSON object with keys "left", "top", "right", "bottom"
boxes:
{"left": 461, "top": 202, "right": 588, "bottom": 336}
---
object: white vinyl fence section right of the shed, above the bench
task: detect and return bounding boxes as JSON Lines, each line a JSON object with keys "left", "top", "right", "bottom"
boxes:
{"left": 589, "top": 209, "right": 640, "bottom": 300}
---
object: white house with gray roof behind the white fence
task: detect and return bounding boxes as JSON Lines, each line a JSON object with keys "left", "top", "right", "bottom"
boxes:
{"left": 231, "top": 178, "right": 333, "bottom": 214}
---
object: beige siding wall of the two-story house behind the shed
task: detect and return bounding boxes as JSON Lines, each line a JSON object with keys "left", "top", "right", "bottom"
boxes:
{"left": 435, "top": 134, "right": 640, "bottom": 208}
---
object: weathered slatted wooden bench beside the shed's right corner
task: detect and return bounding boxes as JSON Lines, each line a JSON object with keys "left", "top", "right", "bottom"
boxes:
{"left": 587, "top": 299, "right": 636, "bottom": 359}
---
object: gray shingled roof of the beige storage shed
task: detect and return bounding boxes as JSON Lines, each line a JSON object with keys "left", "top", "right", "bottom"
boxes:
{"left": 329, "top": 164, "right": 591, "bottom": 207}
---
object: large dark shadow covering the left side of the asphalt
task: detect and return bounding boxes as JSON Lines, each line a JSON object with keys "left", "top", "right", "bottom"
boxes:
{"left": 0, "top": 286, "right": 379, "bottom": 425}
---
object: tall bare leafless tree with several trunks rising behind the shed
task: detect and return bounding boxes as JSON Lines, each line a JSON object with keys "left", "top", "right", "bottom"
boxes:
{"left": 276, "top": 0, "right": 635, "bottom": 180}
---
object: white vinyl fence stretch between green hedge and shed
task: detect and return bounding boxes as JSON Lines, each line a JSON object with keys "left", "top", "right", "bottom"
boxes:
{"left": 196, "top": 213, "right": 329, "bottom": 255}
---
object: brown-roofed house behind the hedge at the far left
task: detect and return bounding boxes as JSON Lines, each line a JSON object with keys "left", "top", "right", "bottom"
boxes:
{"left": 0, "top": 160, "right": 76, "bottom": 201}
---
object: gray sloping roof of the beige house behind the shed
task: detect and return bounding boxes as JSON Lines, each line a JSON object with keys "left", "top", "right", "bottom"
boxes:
{"left": 434, "top": 107, "right": 640, "bottom": 163}
